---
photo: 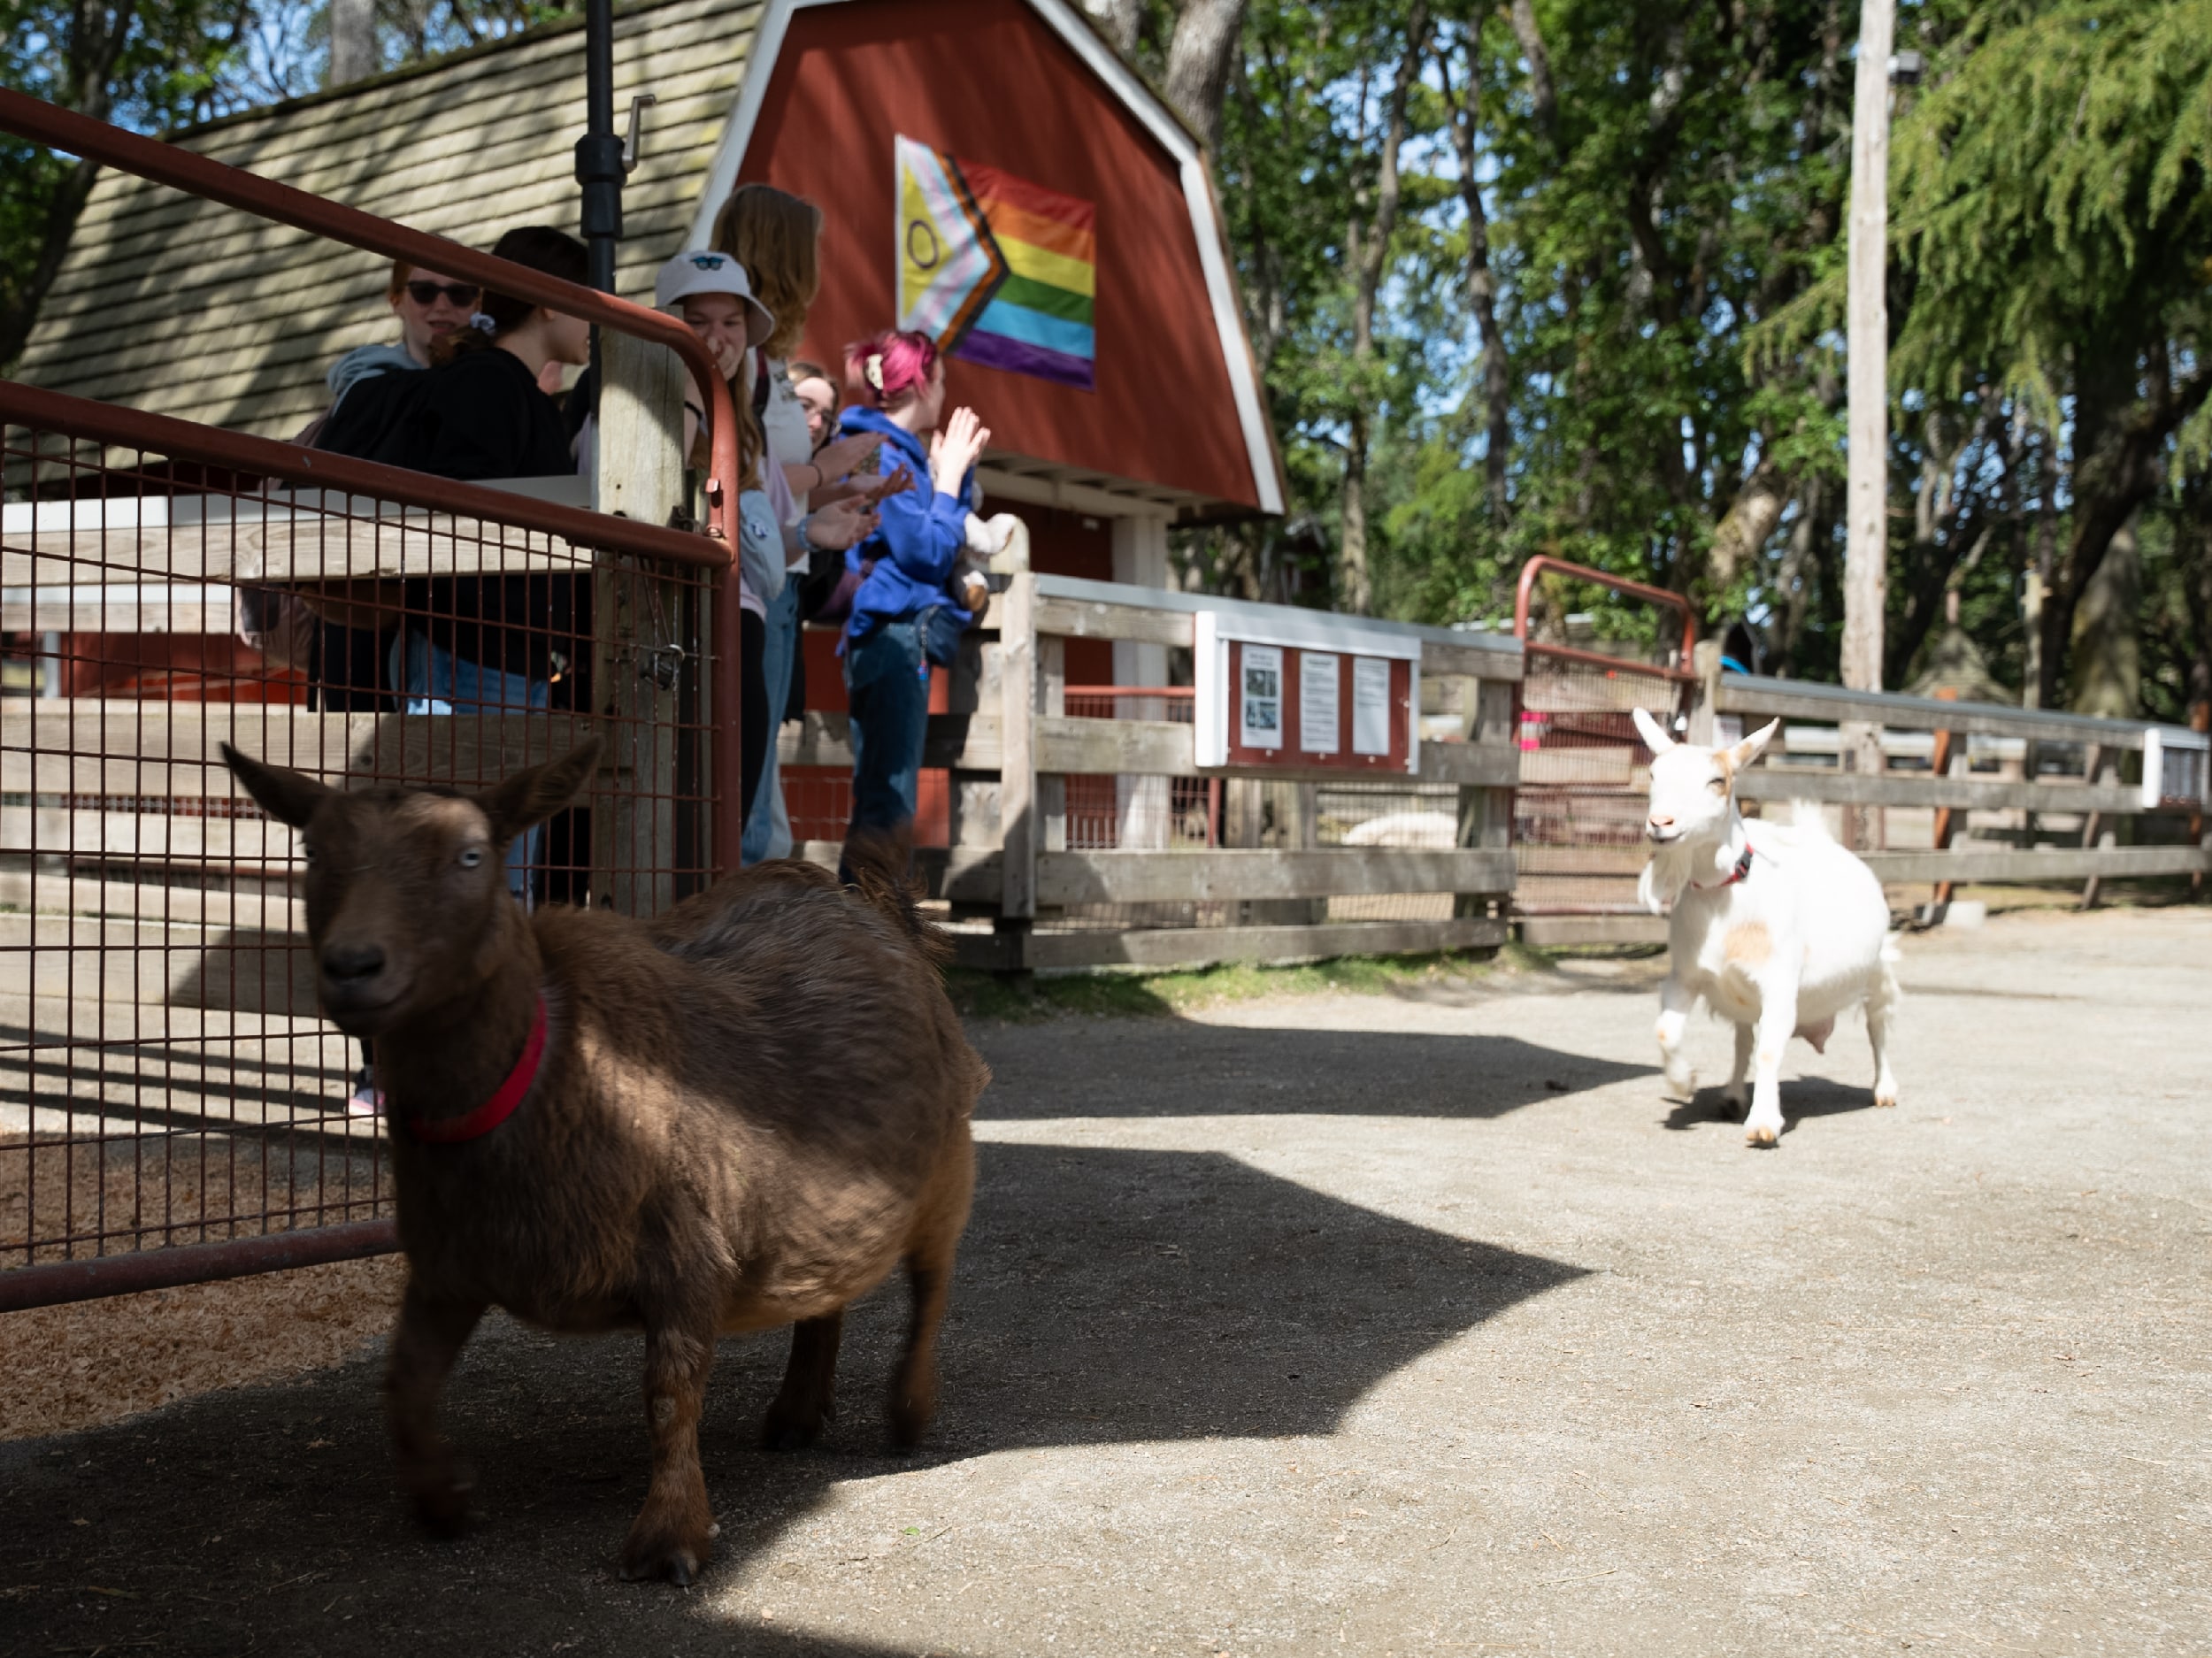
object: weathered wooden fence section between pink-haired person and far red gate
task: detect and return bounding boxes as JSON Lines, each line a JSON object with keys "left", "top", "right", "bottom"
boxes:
{"left": 781, "top": 572, "right": 1522, "bottom": 972}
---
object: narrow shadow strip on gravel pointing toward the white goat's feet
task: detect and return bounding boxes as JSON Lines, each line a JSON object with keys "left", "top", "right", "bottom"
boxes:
{"left": 972, "top": 1019, "right": 1657, "bottom": 1121}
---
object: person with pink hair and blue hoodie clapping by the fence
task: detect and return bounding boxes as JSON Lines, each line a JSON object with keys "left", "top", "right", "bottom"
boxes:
{"left": 841, "top": 329, "right": 991, "bottom": 871}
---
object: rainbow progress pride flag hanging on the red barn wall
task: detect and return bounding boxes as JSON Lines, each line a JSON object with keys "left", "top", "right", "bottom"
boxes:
{"left": 894, "top": 137, "right": 1097, "bottom": 391}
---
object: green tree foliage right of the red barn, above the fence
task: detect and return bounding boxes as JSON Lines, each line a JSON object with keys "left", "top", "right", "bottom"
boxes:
{"left": 1184, "top": 0, "right": 2212, "bottom": 710}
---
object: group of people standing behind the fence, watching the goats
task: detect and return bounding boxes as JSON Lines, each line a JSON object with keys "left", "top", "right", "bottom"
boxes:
{"left": 299, "top": 183, "right": 1009, "bottom": 1109}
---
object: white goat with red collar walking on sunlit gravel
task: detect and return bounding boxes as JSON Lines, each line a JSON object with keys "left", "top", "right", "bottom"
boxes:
{"left": 1637, "top": 708, "right": 1898, "bottom": 1145}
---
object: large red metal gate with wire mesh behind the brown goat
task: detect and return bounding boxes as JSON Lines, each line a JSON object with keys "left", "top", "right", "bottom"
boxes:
{"left": 0, "top": 90, "right": 741, "bottom": 1311}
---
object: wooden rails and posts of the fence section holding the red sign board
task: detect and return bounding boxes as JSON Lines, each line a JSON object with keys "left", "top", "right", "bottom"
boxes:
{"left": 964, "top": 572, "right": 1522, "bottom": 971}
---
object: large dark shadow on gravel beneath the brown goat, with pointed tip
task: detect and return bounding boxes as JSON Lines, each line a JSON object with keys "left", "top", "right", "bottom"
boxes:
{"left": 0, "top": 1145, "right": 1582, "bottom": 1658}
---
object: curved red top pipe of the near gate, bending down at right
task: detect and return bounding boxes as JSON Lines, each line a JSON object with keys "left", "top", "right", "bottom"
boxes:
{"left": 0, "top": 88, "right": 743, "bottom": 871}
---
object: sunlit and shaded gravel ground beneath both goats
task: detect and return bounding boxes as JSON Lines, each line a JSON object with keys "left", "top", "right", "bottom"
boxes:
{"left": 0, "top": 910, "right": 2212, "bottom": 1658}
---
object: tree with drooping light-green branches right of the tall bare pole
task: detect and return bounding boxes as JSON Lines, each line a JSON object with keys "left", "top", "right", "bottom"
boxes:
{"left": 1892, "top": 0, "right": 2212, "bottom": 703}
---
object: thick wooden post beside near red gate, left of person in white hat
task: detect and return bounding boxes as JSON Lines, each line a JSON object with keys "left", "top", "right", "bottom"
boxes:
{"left": 591, "top": 329, "right": 686, "bottom": 915}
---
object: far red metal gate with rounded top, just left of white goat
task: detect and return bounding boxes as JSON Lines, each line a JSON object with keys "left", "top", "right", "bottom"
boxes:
{"left": 1513, "top": 557, "right": 1697, "bottom": 924}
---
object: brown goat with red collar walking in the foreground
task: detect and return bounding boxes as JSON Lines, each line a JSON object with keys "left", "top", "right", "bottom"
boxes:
{"left": 224, "top": 741, "right": 989, "bottom": 1583}
